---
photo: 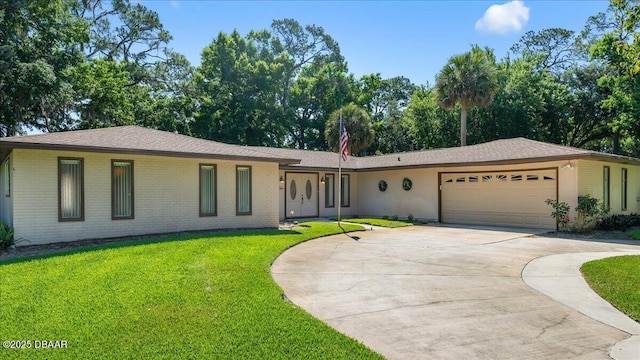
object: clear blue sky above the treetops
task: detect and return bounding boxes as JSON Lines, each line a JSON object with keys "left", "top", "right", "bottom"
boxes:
{"left": 141, "top": 0, "right": 609, "bottom": 84}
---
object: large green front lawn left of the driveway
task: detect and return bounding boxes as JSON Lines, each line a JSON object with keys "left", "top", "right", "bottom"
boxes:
{"left": 0, "top": 223, "right": 380, "bottom": 359}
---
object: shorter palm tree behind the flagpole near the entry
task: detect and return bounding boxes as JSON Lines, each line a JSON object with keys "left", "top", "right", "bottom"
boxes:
{"left": 324, "top": 103, "right": 375, "bottom": 154}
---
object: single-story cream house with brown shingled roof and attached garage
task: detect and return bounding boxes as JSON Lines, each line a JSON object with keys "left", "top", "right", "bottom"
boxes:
{"left": 0, "top": 126, "right": 640, "bottom": 245}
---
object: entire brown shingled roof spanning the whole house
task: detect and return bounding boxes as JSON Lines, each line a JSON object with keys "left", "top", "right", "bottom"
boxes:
{"left": 0, "top": 126, "right": 640, "bottom": 171}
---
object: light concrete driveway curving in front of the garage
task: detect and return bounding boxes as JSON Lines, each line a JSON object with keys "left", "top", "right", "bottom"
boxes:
{"left": 271, "top": 226, "right": 640, "bottom": 359}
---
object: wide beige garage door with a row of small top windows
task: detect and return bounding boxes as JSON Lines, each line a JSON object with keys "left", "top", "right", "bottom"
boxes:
{"left": 440, "top": 169, "right": 558, "bottom": 230}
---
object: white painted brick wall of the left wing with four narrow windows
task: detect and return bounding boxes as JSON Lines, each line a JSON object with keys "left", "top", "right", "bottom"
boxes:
{"left": 12, "top": 149, "right": 278, "bottom": 245}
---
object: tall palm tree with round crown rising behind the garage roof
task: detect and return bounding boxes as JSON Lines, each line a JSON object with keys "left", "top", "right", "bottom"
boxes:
{"left": 436, "top": 46, "right": 499, "bottom": 146}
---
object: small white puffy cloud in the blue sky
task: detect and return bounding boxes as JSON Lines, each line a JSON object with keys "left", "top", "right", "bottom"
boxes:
{"left": 476, "top": 0, "right": 529, "bottom": 34}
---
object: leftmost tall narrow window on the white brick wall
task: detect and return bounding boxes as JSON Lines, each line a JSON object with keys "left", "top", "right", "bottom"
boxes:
{"left": 58, "top": 158, "right": 84, "bottom": 221}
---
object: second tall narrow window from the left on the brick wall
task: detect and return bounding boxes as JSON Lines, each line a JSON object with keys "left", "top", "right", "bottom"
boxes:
{"left": 111, "top": 160, "right": 134, "bottom": 220}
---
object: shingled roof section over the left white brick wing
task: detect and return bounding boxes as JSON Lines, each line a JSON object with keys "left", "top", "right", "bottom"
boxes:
{"left": 0, "top": 126, "right": 300, "bottom": 164}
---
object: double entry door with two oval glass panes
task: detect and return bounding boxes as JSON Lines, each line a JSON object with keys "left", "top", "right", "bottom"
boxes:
{"left": 285, "top": 173, "right": 318, "bottom": 217}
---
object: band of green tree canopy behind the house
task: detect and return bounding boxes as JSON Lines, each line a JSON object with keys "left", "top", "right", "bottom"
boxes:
{"left": 0, "top": 0, "right": 640, "bottom": 157}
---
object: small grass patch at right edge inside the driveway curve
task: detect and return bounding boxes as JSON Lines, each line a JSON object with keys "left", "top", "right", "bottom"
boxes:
{"left": 580, "top": 255, "right": 640, "bottom": 321}
